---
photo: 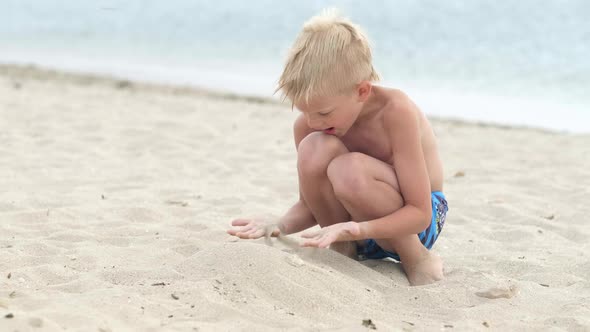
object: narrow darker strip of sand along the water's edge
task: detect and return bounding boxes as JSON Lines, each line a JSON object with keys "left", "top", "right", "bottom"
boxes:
{"left": 0, "top": 63, "right": 590, "bottom": 136}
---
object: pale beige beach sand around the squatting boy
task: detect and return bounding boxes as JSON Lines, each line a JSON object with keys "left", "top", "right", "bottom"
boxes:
{"left": 0, "top": 66, "right": 590, "bottom": 332}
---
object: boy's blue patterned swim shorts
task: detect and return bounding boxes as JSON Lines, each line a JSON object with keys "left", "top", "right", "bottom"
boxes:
{"left": 357, "top": 191, "right": 449, "bottom": 262}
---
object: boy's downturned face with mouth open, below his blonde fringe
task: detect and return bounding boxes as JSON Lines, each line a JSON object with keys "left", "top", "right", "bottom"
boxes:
{"left": 295, "top": 91, "right": 363, "bottom": 137}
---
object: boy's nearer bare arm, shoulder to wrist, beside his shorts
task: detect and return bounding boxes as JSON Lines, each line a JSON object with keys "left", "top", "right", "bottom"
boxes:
{"left": 358, "top": 97, "right": 432, "bottom": 239}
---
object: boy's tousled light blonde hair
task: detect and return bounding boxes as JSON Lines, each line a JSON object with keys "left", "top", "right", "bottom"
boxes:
{"left": 275, "top": 9, "right": 379, "bottom": 104}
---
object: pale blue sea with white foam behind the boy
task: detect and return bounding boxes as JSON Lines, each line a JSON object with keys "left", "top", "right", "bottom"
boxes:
{"left": 0, "top": 0, "right": 590, "bottom": 133}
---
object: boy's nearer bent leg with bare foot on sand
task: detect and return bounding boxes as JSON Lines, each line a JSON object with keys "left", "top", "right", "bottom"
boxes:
{"left": 328, "top": 153, "right": 442, "bottom": 285}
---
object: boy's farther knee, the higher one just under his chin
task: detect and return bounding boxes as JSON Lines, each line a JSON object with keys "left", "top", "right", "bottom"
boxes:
{"left": 297, "top": 132, "right": 347, "bottom": 175}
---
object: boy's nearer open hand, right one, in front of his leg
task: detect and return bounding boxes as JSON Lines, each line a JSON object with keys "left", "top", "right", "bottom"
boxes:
{"left": 301, "top": 221, "right": 361, "bottom": 248}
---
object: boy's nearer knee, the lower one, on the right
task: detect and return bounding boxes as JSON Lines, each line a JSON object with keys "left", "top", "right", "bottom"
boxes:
{"left": 328, "top": 152, "right": 368, "bottom": 200}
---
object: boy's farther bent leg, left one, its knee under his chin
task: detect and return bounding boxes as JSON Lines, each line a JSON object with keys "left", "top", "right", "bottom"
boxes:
{"left": 297, "top": 132, "right": 356, "bottom": 257}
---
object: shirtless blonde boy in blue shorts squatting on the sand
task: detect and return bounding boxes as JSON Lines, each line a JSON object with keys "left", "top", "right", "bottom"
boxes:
{"left": 228, "top": 11, "right": 447, "bottom": 285}
